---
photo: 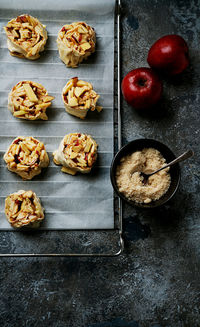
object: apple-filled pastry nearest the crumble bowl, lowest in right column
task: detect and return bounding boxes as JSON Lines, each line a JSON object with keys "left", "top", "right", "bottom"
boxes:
{"left": 53, "top": 133, "right": 98, "bottom": 175}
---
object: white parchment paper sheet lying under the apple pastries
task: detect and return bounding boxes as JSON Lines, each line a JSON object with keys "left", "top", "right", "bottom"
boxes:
{"left": 0, "top": 0, "right": 115, "bottom": 230}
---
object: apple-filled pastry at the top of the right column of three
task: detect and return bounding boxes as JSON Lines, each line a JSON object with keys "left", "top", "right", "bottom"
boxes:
{"left": 57, "top": 22, "right": 96, "bottom": 68}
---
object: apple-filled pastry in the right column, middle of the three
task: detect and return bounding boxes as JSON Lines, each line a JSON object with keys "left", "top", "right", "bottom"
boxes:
{"left": 62, "top": 77, "right": 102, "bottom": 119}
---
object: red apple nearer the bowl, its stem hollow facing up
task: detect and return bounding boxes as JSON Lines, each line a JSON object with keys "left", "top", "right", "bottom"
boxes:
{"left": 122, "top": 67, "right": 162, "bottom": 109}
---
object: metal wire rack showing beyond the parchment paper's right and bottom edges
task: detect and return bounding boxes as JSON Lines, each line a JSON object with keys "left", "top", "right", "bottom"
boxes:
{"left": 0, "top": 0, "right": 124, "bottom": 257}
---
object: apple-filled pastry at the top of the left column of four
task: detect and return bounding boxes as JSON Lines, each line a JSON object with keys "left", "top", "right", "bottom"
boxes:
{"left": 4, "top": 15, "right": 47, "bottom": 60}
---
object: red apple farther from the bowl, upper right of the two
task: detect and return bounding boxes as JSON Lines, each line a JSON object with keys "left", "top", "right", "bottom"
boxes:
{"left": 147, "top": 35, "right": 189, "bottom": 75}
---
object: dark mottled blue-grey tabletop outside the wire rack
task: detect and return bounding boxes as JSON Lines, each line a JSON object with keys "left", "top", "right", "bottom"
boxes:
{"left": 0, "top": 0, "right": 200, "bottom": 327}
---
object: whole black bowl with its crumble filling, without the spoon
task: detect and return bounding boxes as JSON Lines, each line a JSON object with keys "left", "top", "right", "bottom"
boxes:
{"left": 110, "top": 138, "right": 180, "bottom": 209}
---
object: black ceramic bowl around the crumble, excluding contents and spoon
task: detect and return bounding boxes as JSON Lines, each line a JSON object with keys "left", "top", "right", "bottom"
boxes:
{"left": 110, "top": 139, "right": 180, "bottom": 208}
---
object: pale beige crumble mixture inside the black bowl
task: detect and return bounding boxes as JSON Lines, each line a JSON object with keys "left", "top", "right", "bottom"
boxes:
{"left": 116, "top": 148, "right": 171, "bottom": 203}
